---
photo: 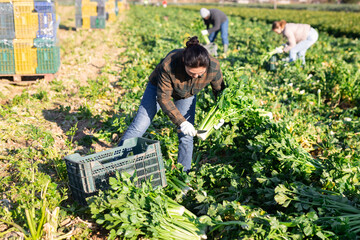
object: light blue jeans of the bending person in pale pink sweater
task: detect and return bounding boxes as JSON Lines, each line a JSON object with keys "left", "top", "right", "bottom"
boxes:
{"left": 289, "top": 28, "right": 319, "bottom": 64}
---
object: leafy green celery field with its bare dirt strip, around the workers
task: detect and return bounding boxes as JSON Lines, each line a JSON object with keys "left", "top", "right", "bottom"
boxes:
{"left": 0, "top": 3, "right": 360, "bottom": 239}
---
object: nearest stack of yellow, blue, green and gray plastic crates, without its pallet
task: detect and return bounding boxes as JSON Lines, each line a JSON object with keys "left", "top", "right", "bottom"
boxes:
{"left": 0, "top": 0, "right": 60, "bottom": 80}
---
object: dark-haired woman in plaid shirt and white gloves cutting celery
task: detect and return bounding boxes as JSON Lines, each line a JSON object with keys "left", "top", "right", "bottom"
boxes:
{"left": 119, "top": 36, "right": 225, "bottom": 172}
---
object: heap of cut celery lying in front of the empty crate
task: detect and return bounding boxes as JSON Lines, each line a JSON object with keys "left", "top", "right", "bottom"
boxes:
{"left": 89, "top": 172, "right": 206, "bottom": 240}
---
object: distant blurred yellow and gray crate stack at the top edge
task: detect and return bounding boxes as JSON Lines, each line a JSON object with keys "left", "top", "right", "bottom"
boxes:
{"left": 75, "top": 0, "right": 124, "bottom": 29}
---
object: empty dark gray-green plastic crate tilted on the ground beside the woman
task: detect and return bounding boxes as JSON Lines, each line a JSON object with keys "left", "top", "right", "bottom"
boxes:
{"left": 65, "top": 138, "right": 166, "bottom": 205}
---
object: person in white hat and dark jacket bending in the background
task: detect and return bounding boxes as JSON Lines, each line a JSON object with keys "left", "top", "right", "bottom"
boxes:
{"left": 200, "top": 8, "right": 229, "bottom": 54}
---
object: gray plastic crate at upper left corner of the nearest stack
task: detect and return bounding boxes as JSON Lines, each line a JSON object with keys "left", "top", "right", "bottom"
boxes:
{"left": 0, "top": 2, "right": 15, "bottom": 39}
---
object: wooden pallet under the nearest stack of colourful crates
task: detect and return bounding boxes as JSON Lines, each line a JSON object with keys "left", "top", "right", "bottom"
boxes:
{"left": 0, "top": 73, "right": 56, "bottom": 85}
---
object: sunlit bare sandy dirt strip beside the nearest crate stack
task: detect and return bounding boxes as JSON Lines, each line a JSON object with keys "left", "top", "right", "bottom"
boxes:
{"left": 0, "top": 6, "right": 125, "bottom": 153}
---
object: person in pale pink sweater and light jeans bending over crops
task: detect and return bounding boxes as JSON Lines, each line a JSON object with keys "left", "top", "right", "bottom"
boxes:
{"left": 272, "top": 20, "right": 319, "bottom": 65}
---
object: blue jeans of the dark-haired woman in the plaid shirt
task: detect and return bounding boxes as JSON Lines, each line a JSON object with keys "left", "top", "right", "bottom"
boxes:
{"left": 119, "top": 83, "right": 196, "bottom": 171}
